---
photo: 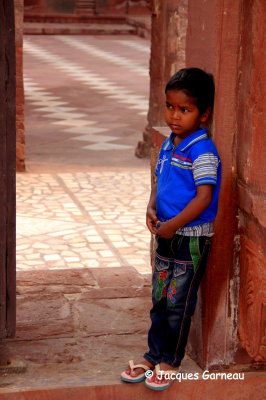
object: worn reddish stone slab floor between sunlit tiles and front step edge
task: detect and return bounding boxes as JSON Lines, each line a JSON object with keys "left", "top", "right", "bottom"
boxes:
{"left": 0, "top": 267, "right": 203, "bottom": 398}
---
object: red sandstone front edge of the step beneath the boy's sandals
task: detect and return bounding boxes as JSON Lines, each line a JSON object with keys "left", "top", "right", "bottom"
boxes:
{"left": 0, "top": 373, "right": 266, "bottom": 400}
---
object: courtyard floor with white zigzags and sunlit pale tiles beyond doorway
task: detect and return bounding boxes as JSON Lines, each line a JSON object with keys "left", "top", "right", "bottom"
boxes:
{"left": 17, "top": 36, "right": 151, "bottom": 274}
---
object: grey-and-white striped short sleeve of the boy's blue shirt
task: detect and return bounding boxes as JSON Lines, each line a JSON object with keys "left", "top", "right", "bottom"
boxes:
{"left": 192, "top": 153, "right": 219, "bottom": 186}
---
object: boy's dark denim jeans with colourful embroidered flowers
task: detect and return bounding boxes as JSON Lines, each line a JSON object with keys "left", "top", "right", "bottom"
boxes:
{"left": 144, "top": 235, "right": 211, "bottom": 367}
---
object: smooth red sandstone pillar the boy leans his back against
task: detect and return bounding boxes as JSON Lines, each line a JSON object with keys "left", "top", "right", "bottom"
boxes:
{"left": 186, "top": 0, "right": 240, "bottom": 367}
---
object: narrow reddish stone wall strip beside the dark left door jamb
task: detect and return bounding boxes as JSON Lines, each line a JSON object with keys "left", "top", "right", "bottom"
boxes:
{"left": 14, "top": 0, "right": 25, "bottom": 172}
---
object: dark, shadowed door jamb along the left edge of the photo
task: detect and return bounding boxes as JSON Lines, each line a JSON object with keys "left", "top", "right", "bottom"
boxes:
{"left": 0, "top": 1, "right": 16, "bottom": 340}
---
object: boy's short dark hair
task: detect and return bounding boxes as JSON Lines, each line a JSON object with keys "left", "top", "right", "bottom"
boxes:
{"left": 165, "top": 68, "right": 215, "bottom": 114}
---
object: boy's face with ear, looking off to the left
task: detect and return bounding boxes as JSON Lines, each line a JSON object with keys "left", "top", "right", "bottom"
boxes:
{"left": 165, "top": 90, "right": 210, "bottom": 139}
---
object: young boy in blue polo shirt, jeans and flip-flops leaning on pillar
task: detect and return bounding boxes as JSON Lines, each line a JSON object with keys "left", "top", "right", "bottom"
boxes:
{"left": 121, "top": 68, "right": 221, "bottom": 390}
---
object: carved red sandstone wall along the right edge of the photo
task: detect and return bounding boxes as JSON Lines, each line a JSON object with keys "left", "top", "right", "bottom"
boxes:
{"left": 236, "top": 0, "right": 266, "bottom": 361}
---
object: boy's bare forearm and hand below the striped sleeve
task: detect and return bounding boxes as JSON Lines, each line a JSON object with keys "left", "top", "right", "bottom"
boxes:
{"left": 156, "top": 185, "right": 213, "bottom": 238}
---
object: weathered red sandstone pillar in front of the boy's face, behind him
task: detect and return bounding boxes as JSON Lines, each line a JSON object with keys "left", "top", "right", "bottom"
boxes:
{"left": 136, "top": 0, "right": 187, "bottom": 157}
